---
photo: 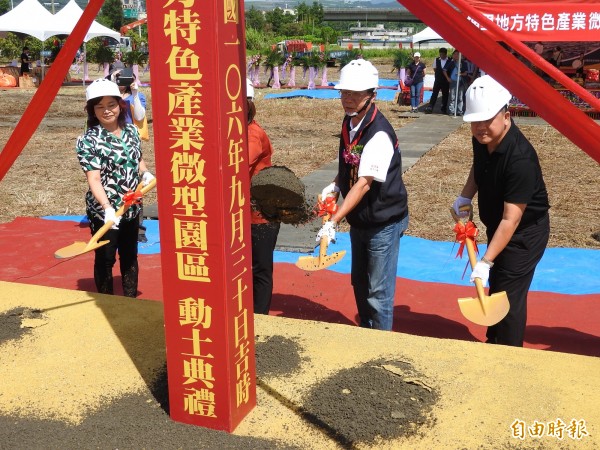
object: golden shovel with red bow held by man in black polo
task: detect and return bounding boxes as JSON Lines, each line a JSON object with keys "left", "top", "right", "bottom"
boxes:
{"left": 450, "top": 207, "right": 510, "bottom": 326}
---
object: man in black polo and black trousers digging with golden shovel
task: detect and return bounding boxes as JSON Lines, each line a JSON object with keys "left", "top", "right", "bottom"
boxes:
{"left": 452, "top": 75, "right": 550, "bottom": 347}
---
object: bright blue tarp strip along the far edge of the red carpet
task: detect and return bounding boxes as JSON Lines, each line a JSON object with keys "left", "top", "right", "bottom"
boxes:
{"left": 44, "top": 216, "right": 600, "bottom": 295}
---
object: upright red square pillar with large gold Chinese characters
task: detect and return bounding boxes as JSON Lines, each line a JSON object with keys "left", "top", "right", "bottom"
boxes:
{"left": 147, "top": 0, "right": 256, "bottom": 432}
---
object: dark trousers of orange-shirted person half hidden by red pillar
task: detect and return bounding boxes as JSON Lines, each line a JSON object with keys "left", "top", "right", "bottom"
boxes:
{"left": 251, "top": 223, "right": 280, "bottom": 314}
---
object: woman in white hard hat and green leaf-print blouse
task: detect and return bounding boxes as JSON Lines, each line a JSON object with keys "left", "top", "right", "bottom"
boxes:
{"left": 76, "top": 79, "right": 154, "bottom": 297}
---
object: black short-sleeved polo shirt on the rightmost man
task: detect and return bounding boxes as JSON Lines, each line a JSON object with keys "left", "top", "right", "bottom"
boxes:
{"left": 473, "top": 119, "right": 550, "bottom": 239}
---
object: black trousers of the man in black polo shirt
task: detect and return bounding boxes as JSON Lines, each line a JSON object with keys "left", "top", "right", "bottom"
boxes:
{"left": 486, "top": 214, "right": 550, "bottom": 347}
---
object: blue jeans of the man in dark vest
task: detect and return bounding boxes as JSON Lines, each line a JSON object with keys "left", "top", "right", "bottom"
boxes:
{"left": 350, "top": 216, "right": 408, "bottom": 330}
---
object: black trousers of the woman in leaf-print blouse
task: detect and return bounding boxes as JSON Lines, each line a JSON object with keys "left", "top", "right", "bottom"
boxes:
{"left": 90, "top": 217, "right": 140, "bottom": 298}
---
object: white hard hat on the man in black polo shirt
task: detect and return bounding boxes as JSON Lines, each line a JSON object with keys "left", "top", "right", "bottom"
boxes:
{"left": 463, "top": 75, "right": 512, "bottom": 122}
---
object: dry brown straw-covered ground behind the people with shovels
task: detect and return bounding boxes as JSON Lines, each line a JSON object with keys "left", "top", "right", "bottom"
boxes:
{"left": 0, "top": 60, "right": 600, "bottom": 248}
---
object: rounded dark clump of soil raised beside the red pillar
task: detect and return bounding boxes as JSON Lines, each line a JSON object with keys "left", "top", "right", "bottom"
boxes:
{"left": 250, "top": 166, "right": 314, "bottom": 225}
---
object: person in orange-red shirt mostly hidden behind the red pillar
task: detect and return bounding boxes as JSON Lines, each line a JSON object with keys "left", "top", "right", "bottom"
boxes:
{"left": 246, "top": 79, "right": 280, "bottom": 314}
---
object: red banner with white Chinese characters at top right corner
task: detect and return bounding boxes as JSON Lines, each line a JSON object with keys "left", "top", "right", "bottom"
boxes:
{"left": 468, "top": 0, "right": 600, "bottom": 41}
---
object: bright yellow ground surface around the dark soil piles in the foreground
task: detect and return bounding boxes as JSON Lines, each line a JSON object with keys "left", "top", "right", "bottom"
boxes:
{"left": 0, "top": 282, "right": 600, "bottom": 450}
